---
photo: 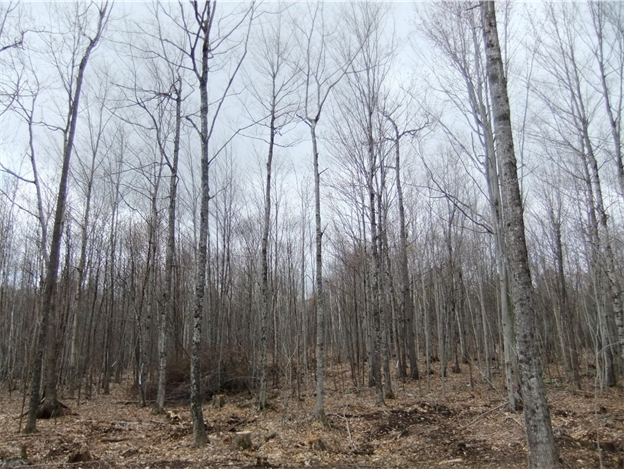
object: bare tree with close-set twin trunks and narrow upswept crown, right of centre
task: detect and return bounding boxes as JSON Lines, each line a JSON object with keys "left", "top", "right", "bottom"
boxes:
{"left": 339, "top": 3, "right": 394, "bottom": 405}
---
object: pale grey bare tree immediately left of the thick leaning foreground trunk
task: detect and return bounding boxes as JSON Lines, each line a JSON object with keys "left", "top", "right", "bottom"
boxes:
{"left": 424, "top": 2, "right": 519, "bottom": 409}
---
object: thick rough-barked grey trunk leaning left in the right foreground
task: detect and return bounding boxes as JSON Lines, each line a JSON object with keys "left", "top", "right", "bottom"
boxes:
{"left": 481, "top": 1, "right": 560, "bottom": 469}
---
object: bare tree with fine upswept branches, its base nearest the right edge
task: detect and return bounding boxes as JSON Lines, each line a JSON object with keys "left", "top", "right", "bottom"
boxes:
{"left": 534, "top": 4, "right": 624, "bottom": 386}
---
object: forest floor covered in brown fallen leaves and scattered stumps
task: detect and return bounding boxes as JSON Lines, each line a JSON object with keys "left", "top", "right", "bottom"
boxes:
{"left": 0, "top": 366, "right": 624, "bottom": 469}
